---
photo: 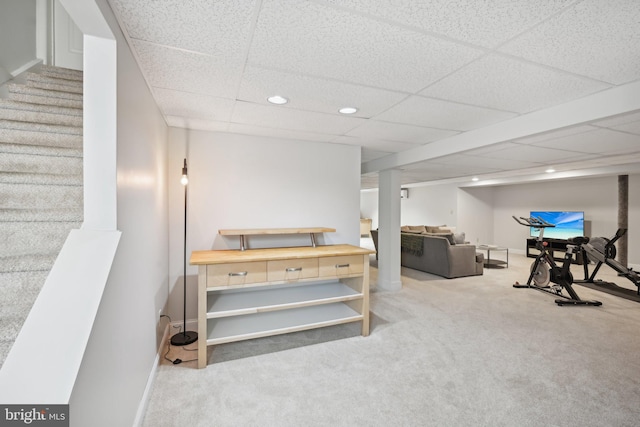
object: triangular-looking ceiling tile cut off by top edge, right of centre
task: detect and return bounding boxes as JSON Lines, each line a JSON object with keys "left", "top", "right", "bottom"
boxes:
{"left": 324, "top": 0, "right": 574, "bottom": 47}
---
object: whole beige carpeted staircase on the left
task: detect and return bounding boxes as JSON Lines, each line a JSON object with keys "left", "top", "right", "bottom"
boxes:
{"left": 0, "top": 65, "right": 83, "bottom": 366}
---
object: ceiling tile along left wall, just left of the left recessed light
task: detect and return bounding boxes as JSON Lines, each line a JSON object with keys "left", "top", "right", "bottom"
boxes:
{"left": 154, "top": 89, "right": 235, "bottom": 121}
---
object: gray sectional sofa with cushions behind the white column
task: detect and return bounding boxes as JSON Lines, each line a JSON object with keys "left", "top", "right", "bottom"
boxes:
{"left": 371, "top": 230, "right": 484, "bottom": 279}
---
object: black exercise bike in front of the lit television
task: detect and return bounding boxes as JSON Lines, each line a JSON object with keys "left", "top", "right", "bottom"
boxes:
{"left": 513, "top": 216, "right": 602, "bottom": 306}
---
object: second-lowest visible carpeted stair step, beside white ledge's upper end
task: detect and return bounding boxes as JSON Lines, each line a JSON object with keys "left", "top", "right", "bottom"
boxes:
{"left": 0, "top": 222, "right": 77, "bottom": 257}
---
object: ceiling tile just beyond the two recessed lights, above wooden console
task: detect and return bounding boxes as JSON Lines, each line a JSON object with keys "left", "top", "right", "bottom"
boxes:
{"left": 232, "top": 102, "right": 365, "bottom": 135}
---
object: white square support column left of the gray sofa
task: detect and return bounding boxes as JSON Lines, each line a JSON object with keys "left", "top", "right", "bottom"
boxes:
{"left": 378, "top": 169, "right": 402, "bottom": 291}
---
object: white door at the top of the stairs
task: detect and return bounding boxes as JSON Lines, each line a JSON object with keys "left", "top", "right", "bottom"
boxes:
{"left": 53, "top": 0, "right": 82, "bottom": 70}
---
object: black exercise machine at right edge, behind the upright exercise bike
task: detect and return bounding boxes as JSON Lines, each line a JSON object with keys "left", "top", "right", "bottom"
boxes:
{"left": 575, "top": 228, "right": 640, "bottom": 295}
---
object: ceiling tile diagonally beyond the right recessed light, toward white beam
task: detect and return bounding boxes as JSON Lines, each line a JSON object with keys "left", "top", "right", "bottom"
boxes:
{"left": 347, "top": 120, "right": 456, "bottom": 144}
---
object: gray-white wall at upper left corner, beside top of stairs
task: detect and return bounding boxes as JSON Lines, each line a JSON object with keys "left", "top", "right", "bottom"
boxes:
{"left": 0, "top": 0, "right": 36, "bottom": 83}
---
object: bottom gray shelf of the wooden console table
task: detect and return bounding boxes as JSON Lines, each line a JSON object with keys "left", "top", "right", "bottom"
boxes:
{"left": 207, "top": 303, "right": 368, "bottom": 345}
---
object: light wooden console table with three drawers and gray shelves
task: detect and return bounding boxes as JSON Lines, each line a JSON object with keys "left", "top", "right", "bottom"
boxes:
{"left": 191, "top": 236, "right": 374, "bottom": 368}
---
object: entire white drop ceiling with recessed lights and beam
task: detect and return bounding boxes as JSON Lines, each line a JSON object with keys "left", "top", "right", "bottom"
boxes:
{"left": 109, "top": 0, "right": 640, "bottom": 188}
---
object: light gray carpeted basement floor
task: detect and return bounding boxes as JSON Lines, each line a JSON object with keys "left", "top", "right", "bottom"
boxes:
{"left": 143, "top": 242, "right": 640, "bottom": 427}
